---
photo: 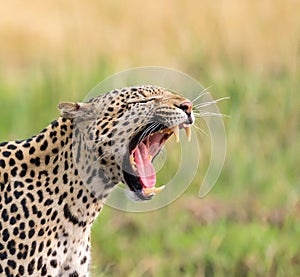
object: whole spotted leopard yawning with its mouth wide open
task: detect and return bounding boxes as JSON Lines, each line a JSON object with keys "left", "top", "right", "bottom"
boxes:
{"left": 0, "top": 85, "right": 195, "bottom": 277}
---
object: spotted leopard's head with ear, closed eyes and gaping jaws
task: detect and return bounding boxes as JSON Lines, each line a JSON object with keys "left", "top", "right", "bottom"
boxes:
{"left": 59, "top": 86, "right": 194, "bottom": 200}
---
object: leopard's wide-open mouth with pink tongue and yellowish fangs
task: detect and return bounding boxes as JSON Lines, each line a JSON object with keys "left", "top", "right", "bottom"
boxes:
{"left": 123, "top": 123, "right": 191, "bottom": 200}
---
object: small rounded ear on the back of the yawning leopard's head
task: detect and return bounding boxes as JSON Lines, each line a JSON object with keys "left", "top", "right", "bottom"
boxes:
{"left": 58, "top": 102, "right": 94, "bottom": 119}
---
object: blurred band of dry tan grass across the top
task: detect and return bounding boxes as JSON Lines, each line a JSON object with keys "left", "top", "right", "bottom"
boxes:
{"left": 0, "top": 0, "right": 300, "bottom": 74}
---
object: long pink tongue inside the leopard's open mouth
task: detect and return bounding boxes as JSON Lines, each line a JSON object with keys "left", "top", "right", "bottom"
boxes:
{"left": 134, "top": 142, "right": 156, "bottom": 188}
